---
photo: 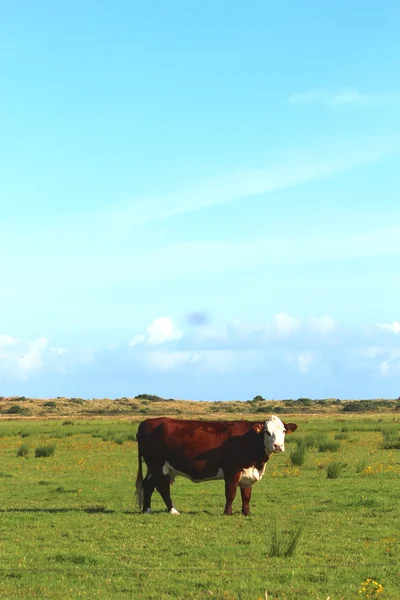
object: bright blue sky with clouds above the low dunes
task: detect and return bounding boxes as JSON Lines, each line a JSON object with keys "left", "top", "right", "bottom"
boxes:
{"left": 0, "top": 0, "right": 400, "bottom": 400}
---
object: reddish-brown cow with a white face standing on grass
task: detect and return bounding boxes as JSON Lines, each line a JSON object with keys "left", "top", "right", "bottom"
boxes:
{"left": 136, "top": 415, "right": 297, "bottom": 516}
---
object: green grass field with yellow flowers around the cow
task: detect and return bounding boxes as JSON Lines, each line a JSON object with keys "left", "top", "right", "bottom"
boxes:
{"left": 0, "top": 407, "right": 400, "bottom": 600}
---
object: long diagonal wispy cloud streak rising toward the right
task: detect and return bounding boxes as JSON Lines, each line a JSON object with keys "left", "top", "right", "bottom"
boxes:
{"left": 104, "top": 140, "right": 393, "bottom": 232}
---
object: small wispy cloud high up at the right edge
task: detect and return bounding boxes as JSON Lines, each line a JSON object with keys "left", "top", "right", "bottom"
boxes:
{"left": 289, "top": 88, "right": 400, "bottom": 108}
